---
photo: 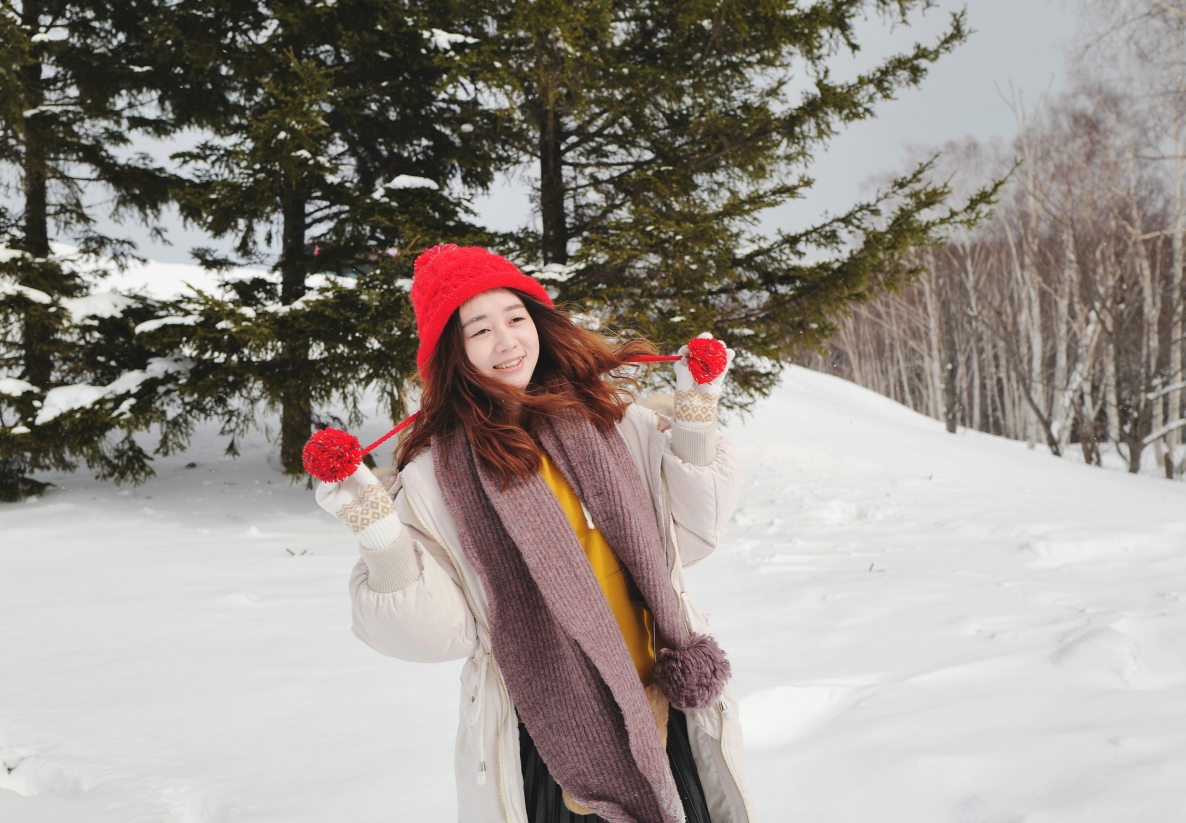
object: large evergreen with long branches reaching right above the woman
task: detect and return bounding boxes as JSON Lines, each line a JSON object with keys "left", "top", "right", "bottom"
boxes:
{"left": 457, "top": 0, "right": 990, "bottom": 406}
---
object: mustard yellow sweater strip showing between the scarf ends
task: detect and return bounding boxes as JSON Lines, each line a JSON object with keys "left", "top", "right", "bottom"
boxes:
{"left": 540, "top": 454, "right": 655, "bottom": 683}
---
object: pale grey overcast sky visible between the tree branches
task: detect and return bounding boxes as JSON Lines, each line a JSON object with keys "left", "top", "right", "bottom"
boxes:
{"left": 90, "top": 0, "right": 1076, "bottom": 262}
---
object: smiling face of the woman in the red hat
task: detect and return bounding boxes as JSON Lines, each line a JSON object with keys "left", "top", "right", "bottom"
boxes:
{"left": 459, "top": 288, "right": 540, "bottom": 389}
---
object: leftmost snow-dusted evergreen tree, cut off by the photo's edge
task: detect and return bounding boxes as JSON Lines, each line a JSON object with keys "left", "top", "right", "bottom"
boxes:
{"left": 0, "top": 0, "right": 184, "bottom": 500}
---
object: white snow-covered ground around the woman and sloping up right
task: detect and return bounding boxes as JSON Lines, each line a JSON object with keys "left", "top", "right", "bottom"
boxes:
{"left": 0, "top": 369, "right": 1186, "bottom": 823}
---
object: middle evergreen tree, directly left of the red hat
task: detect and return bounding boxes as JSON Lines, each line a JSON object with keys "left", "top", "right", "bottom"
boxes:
{"left": 146, "top": 0, "right": 498, "bottom": 476}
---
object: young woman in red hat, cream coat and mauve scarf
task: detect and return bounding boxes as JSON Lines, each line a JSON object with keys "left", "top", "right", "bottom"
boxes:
{"left": 317, "top": 245, "right": 752, "bottom": 823}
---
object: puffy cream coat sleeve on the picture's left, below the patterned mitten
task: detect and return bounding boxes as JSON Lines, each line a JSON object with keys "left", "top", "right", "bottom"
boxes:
{"left": 350, "top": 490, "right": 478, "bottom": 663}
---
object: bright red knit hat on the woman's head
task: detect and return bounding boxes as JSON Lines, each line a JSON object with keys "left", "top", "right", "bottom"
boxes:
{"left": 412, "top": 243, "right": 551, "bottom": 375}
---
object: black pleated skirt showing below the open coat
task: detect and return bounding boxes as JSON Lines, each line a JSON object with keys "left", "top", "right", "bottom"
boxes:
{"left": 519, "top": 708, "right": 712, "bottom": 823}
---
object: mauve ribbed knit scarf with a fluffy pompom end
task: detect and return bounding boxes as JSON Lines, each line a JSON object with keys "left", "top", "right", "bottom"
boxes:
{"left": 432, "top": 415, "right": 729, "bottom": 823}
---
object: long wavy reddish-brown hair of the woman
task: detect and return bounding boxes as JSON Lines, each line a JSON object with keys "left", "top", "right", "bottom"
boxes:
{"left": 395, "top": 289, "right": 655, "bottom": 486}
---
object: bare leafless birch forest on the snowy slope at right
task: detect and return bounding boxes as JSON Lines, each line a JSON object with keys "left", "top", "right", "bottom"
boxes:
{"left": 809, "top": 0, "right": 1186, "bottom": 478}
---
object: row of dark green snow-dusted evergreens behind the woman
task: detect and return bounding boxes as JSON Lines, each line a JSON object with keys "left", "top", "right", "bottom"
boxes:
{"left": 0, "top": 0, "right": 990, "bottom": 500}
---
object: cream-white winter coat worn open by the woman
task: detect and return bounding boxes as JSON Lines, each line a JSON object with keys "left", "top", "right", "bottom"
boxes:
{"left": 350, "top": 406, "right": 754, "bottom": 823}
